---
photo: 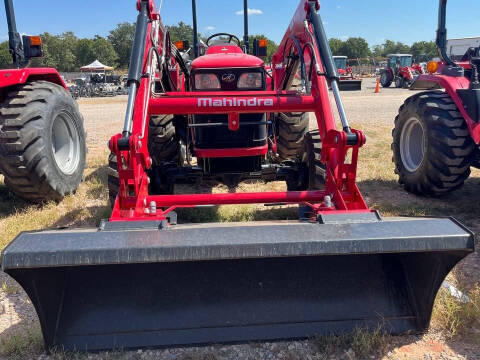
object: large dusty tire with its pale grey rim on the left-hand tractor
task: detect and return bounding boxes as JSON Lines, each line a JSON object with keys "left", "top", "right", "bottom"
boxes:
{"left": 0, "top": 81, "right": 86, "bottom": 203}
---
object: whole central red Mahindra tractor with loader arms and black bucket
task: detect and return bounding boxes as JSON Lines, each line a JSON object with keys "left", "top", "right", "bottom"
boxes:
{"left": 2, "top": 0, "right": 474, "bottom": 350}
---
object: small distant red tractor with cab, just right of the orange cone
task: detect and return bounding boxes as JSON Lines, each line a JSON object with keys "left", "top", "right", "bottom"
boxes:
{"left": 380, "top": 54, "right": 424, "bottom": 88}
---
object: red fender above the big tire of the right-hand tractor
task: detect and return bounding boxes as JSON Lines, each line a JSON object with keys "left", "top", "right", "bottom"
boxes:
{"left": 410, "top": 74, "right": 480, "bottom": 145}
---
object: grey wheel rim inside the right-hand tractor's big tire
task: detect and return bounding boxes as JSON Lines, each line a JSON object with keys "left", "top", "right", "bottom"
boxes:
{"left": 400, "top": 117, "right": 425, "bottom": 172}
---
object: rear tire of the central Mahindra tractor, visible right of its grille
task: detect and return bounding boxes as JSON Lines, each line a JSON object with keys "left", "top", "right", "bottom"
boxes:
{"left": 277, "top": 113, "right": 310, "bottom": 162}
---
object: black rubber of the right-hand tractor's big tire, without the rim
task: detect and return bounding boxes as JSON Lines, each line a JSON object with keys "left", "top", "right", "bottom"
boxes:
{"left": 392, "top": 91, "right": 475, "bottom": 196}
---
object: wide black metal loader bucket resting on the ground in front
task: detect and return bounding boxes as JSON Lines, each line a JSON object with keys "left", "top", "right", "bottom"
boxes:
{"left": 2, "top": 218, "right": 474, "bottom": 350}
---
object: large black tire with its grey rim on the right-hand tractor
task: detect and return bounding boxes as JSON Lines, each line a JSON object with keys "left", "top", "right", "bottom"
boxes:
{"left": 392, "top": 91, "right": 475, "bottom": 196}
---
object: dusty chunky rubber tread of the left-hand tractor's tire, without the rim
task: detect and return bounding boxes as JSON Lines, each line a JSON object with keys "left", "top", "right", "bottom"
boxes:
{"left": 0, "top": 81, "right": 84, "bottom": 203}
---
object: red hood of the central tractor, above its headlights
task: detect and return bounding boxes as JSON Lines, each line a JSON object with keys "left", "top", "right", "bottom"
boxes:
{"left": 192, "top": 45, "right": 263, "bottom": 69}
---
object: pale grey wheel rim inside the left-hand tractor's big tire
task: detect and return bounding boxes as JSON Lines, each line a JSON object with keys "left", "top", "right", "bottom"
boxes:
{"left": 52, "top": 112, "right": 80, "bottom": 175}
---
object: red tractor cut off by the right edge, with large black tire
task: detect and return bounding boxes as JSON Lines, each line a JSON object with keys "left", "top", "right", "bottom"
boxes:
{"left": 392, "top": 0, "right": 480, "bottom": 196}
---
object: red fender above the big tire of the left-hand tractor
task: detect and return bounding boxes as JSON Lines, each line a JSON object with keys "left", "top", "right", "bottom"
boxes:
{"left": 0, "top": 68, "right": 68, "bottom": 91}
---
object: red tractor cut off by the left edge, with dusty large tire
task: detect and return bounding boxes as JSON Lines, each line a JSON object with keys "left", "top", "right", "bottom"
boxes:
{"left": 0, "top": 0, "right": 86, "bottom": 202}
